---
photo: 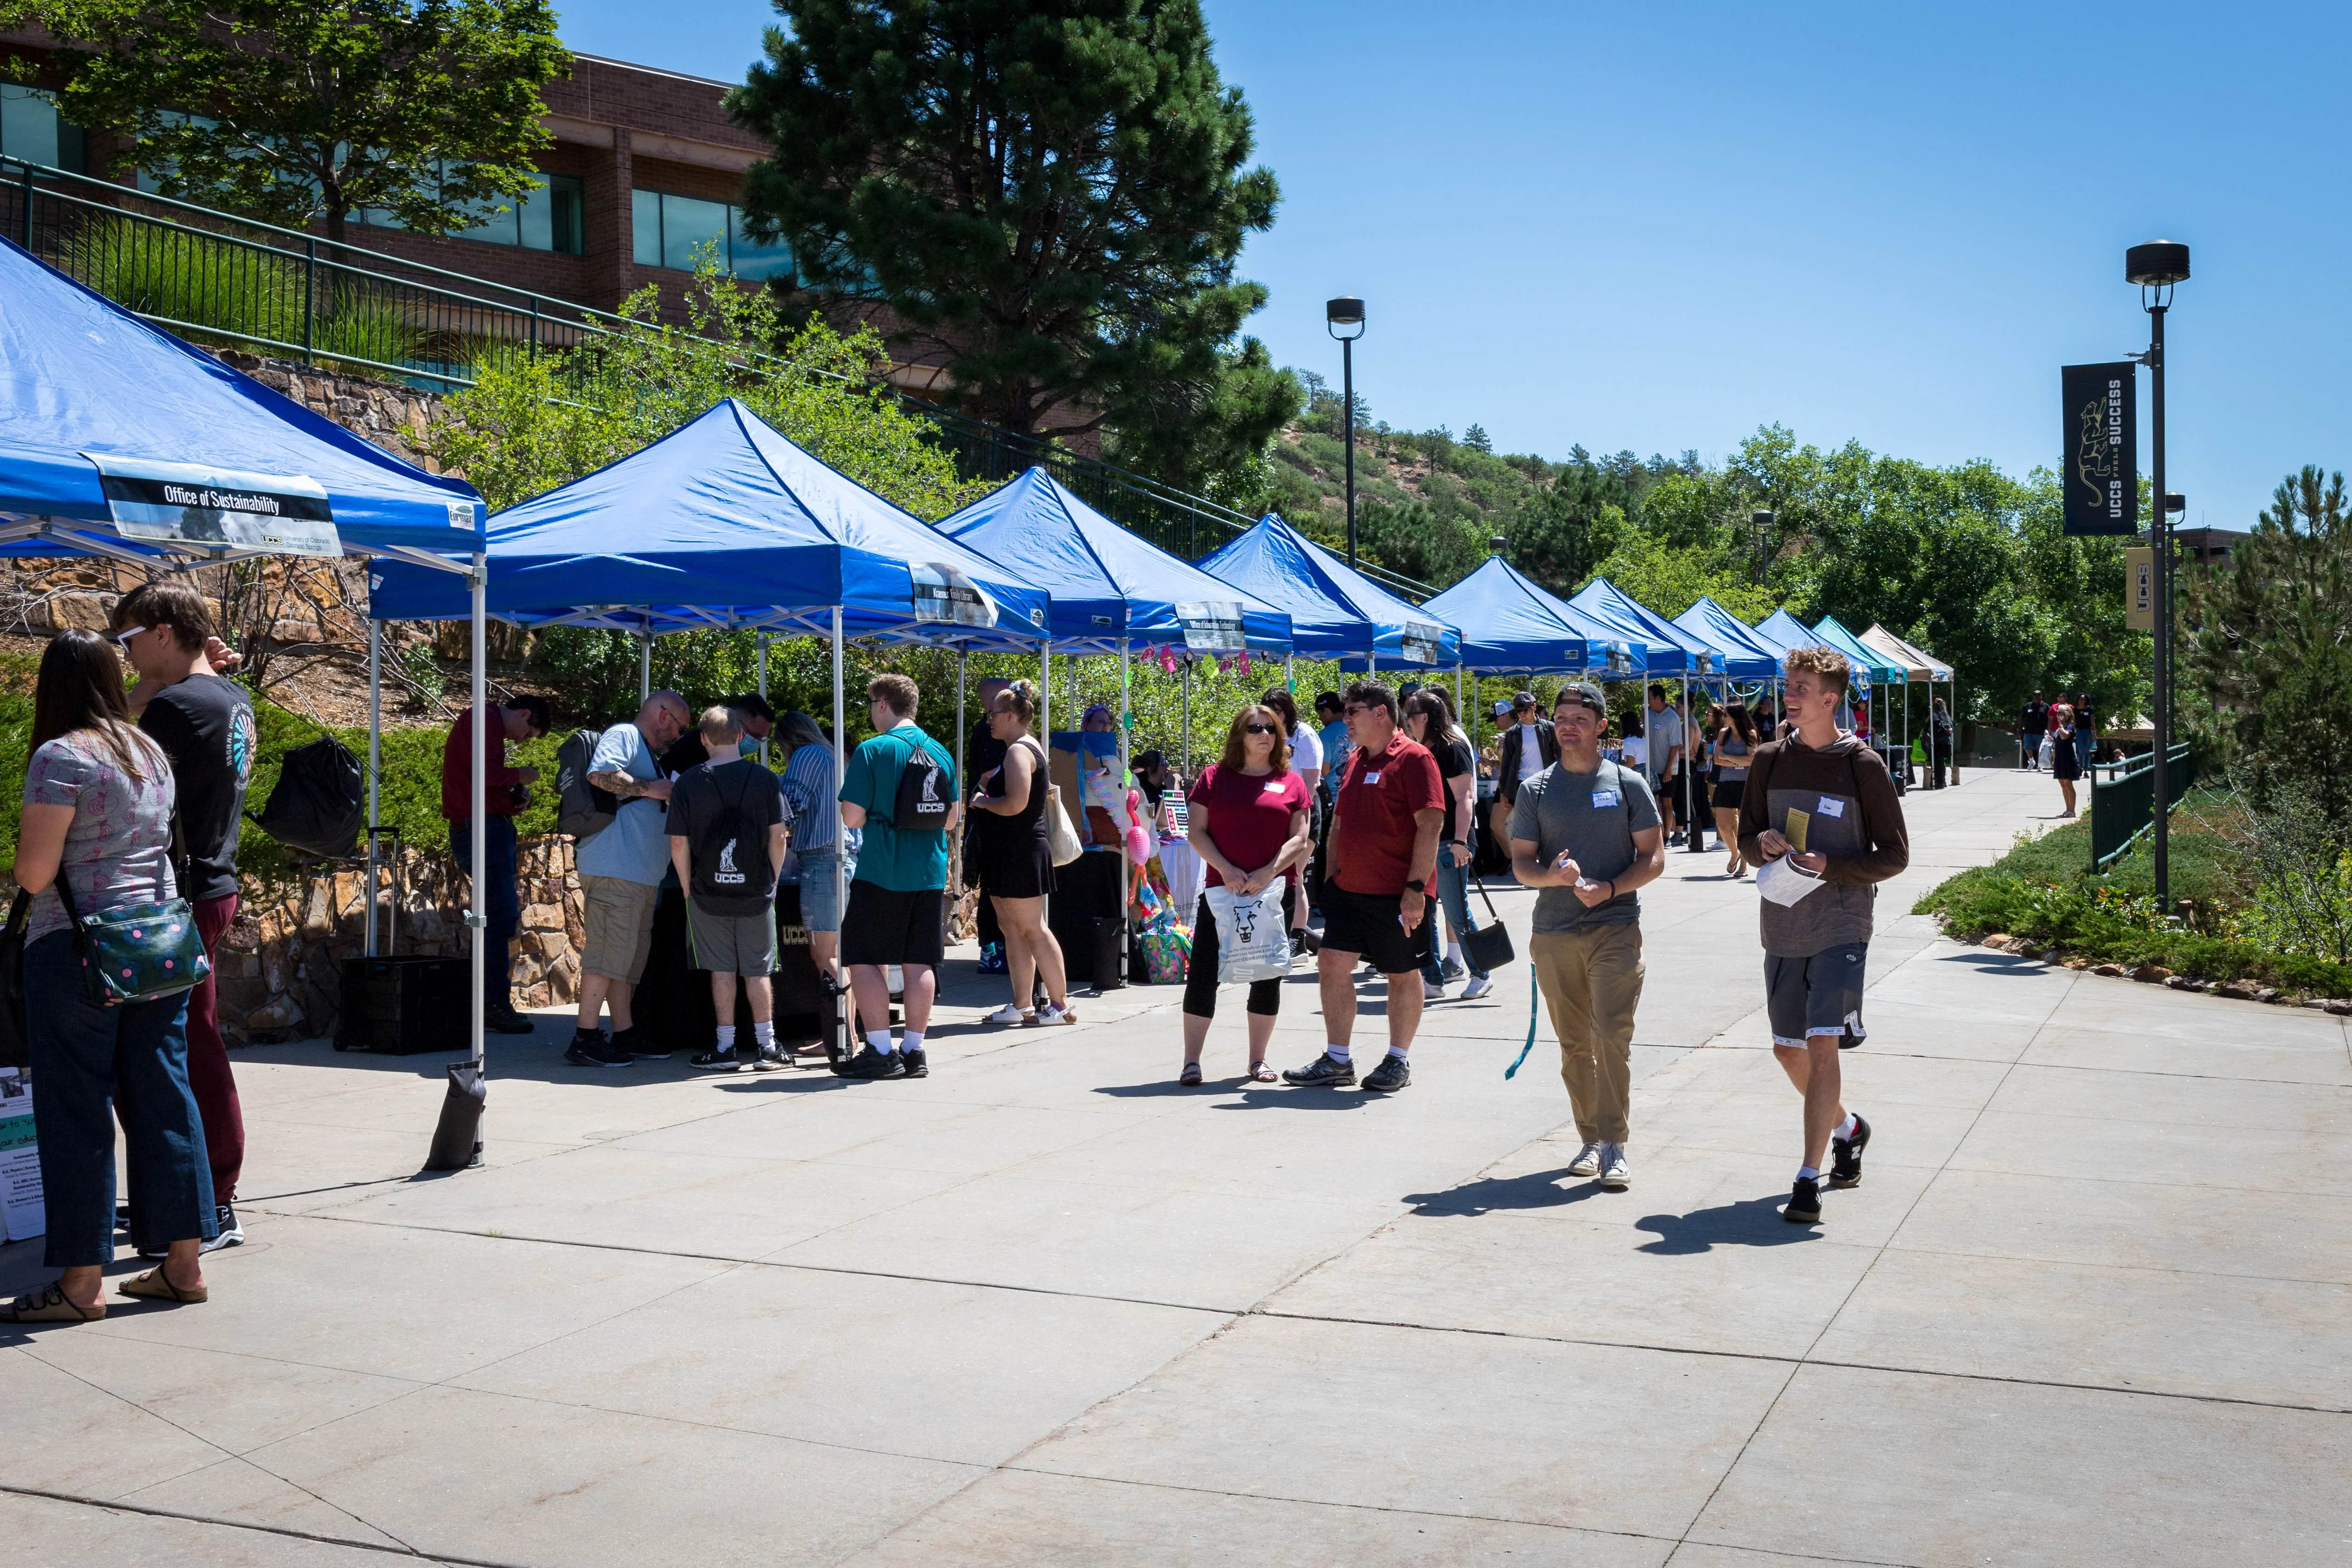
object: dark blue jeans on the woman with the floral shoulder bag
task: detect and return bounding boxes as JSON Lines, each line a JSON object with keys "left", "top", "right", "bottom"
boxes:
{"left": 24, "top": 931, "right": 219, "bottom": 1270}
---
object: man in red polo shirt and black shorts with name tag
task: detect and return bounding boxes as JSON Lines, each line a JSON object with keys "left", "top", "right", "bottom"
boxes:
{"left": 1282, "top": 680, "right": 1446, "bottom": 1093}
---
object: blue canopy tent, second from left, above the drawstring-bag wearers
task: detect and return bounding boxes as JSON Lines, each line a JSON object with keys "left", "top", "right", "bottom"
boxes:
{"left": 369, "top": 397, "right": 1049, "bottom": 1030}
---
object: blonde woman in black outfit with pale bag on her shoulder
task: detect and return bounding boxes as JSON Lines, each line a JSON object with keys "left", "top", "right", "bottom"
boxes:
{"left": 967, "top": 680, "right": 1075, "bottom": 1025}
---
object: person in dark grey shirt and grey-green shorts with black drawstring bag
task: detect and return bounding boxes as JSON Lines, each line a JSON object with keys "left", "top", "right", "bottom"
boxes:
{"left": 670, "top": 707, "right": 793, "bottom": 1072}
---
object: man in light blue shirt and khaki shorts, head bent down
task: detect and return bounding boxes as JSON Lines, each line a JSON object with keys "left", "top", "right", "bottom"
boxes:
{"left": 564, "top": 691, "right": 692, "bottom": 1067}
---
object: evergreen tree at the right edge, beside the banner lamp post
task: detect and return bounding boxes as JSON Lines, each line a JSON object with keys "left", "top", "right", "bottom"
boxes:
{"left": 2185, "top": 468, "right": 2352, "bottom": 837}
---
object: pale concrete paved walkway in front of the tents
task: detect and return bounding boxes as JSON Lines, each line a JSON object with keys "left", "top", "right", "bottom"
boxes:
{"left": 0, "top": 774, "right": 2352, "bottom": 1568}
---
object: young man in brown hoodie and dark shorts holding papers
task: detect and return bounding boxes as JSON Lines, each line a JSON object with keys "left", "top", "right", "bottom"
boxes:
{"left": 1740, "top": 649, "right": 1910, "bottom": 1225}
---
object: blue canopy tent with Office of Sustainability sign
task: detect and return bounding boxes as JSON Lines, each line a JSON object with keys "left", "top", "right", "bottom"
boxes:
{"left": 0, "top": 240, "right": 508, "bottom": 1114}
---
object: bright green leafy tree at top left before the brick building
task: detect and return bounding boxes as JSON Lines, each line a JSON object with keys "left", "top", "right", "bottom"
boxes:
{"left": 43, "top": 0, "right": 571, "bottom": 240}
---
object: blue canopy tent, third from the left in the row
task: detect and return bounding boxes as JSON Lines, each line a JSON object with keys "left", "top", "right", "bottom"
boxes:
{"left": 939, "top": 468, "right": 1291, "bottom": 771}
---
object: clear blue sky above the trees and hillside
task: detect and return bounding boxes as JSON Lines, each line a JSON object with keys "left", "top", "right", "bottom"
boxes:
{"left": 562, "top": 0, "right": 2352, "bottom": 526}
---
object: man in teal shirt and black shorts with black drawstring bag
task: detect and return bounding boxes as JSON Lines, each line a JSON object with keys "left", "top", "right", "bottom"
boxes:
{"left": 833, "top": 675, "right": 964, "bottom": 1079}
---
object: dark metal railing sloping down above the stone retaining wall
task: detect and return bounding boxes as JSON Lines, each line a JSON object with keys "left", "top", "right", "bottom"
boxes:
{"left": 0, "top": 155, "right": 1437, "bottom": 602}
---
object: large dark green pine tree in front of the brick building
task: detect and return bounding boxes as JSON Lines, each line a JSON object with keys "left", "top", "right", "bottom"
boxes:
{"left": 727, "top": 0, "right": 1301, "bottom": 482}
